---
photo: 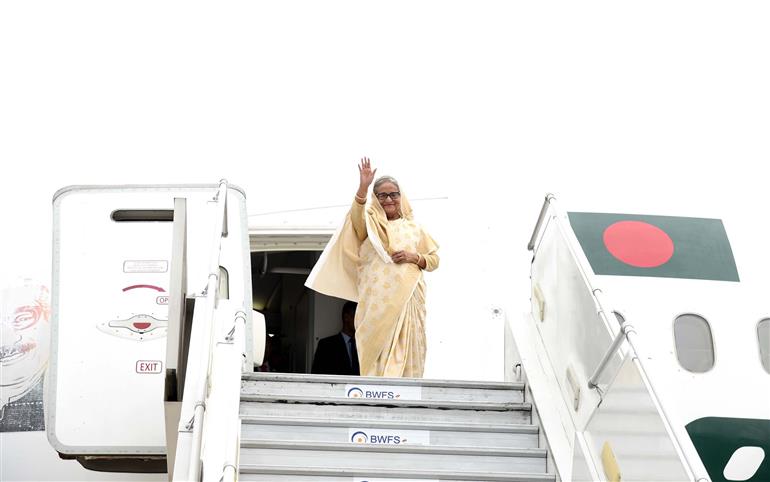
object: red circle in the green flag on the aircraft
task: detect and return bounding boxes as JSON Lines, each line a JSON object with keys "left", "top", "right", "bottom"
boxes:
{"left": 604, "top": 221, "right": 674, "bottom": 268}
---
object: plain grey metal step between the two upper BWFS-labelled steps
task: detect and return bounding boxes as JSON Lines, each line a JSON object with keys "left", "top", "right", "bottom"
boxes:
{"left": 241, "top": 400, "right": 532, "bottom": 426}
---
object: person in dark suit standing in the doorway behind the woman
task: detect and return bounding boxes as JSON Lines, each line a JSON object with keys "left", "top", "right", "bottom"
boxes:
{"left": 311, "top": 301, "right": 359, "bottom": 375}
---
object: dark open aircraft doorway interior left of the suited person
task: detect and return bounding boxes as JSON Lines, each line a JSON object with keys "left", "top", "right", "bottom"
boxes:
{"left": 251, "top": 251, "right": 345, "bottom": 373}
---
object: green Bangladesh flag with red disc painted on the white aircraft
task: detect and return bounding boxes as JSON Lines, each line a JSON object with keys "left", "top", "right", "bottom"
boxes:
{"left": 568, "top": 213, "right": 740, "bottom": 281}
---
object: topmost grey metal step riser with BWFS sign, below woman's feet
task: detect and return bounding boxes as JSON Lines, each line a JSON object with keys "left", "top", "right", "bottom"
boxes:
{"left": 242, "top": 374, "right": 524, "bottom": 403}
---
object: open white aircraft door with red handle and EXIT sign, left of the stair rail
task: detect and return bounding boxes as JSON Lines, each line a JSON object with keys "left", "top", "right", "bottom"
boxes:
{"left": 46, "top": 187, "right": 198, "bottom": 454}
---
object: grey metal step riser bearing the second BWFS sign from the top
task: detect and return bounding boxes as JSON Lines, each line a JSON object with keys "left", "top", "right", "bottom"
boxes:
{"left": 241, "top": 417, "right": 538, "bottom": 448}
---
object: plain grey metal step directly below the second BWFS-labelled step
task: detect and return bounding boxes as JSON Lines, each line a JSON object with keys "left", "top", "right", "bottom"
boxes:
{"left": 240, "top": 441, "right": 546, "bottom": 474}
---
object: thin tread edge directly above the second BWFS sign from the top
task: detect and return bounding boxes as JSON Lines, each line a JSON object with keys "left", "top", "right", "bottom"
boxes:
{"left": 241, "top": 415, "right": 540, "bottom": 434}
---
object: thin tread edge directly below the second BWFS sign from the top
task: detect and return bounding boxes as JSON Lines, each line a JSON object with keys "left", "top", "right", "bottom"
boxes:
{"left": 241, "top": 440, "right": 547, "bottom": 457}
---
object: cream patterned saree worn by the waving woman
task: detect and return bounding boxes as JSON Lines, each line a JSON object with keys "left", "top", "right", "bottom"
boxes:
{"left": 305, "top": 194, "right": 439, "bottom": 378}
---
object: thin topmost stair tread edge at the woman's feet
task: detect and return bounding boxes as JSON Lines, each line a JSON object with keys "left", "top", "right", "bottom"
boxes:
{"left": 242, "top": 372, "right": 524, "bottom": 390}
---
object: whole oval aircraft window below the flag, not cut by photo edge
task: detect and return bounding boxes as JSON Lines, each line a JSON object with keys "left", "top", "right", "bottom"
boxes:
{"left": 674, "top": 314, "right": 714, "bottom": 373}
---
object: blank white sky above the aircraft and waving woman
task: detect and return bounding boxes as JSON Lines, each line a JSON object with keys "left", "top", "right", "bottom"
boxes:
{"left": 0, "top": 1, "right": 770, "bottom": 294}
